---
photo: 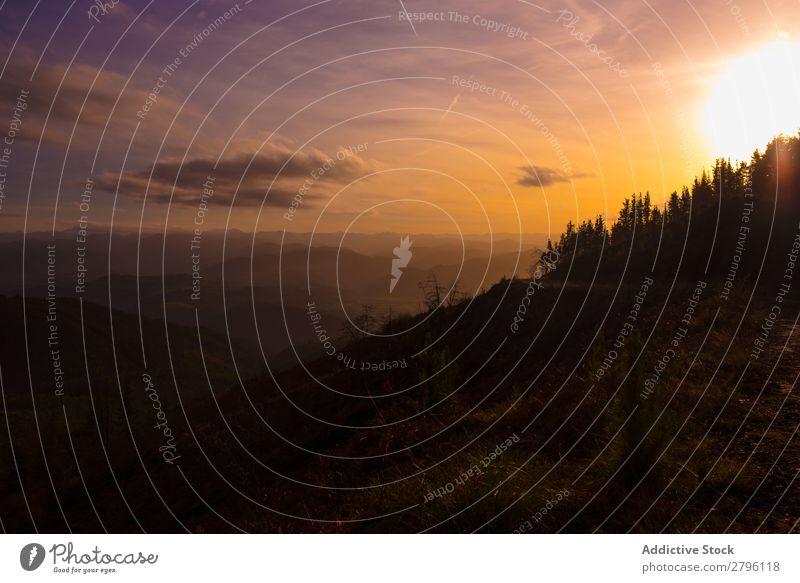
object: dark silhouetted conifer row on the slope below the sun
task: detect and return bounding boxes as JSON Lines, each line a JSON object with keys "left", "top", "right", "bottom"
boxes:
{"left": 543, "top": 133, "right": 800, "bottom": 280}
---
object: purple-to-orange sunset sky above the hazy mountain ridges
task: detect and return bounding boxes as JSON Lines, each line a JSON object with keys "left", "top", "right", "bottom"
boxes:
{"left": 0, "top": 0, "right": 800, "bottom": 242}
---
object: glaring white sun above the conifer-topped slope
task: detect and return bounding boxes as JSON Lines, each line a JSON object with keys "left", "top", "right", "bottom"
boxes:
{"left": 704, "top": 39, "right": 800, "bottom": 161}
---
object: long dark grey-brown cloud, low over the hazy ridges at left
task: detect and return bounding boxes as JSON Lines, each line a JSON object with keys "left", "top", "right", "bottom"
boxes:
{"left": 95, "top": 143, "right": 376, "bottom": 206}
